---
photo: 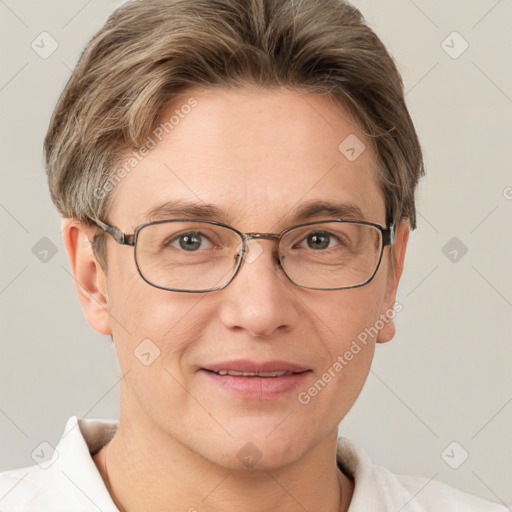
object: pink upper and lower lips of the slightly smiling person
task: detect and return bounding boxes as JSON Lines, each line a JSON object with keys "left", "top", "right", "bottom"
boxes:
{"left": 201, "top": 360, "right": 311, "bottom": 400}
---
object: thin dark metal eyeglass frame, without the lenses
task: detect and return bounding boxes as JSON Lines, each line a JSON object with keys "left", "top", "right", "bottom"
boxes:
{"left": 89, "top": 218, "right": 396, "bottom": 293}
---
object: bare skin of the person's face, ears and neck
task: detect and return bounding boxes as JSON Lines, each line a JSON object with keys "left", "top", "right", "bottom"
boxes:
{"left": 64, "top": 88, "right": 409, "bottom": 512}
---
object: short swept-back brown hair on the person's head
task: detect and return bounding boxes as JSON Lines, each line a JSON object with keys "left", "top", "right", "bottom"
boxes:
{"left": 44, "top": 0, "right": 425, "bottom": 268}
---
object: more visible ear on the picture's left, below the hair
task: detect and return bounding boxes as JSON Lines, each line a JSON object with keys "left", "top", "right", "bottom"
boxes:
{"left": 62, "top": 218, "right": 112, "bottom": 335}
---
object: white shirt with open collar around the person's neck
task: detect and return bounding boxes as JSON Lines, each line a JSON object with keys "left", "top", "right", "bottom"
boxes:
{"left": 0, "top": 416, "right": 509, "bottom": 512}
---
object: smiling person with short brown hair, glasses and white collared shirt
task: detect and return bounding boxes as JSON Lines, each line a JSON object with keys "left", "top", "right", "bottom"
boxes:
{"left": 0, "top": 0, "right": 506, "bottom": 512}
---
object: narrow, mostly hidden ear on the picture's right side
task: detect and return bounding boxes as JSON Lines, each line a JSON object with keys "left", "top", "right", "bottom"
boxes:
{"left": 377, "top": 221, "right": 410, "bottom": 343}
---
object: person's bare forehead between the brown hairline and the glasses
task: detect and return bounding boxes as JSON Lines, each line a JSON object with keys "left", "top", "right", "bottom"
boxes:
{"left": 109, "top": 88, "right": 385, "bottom": 231}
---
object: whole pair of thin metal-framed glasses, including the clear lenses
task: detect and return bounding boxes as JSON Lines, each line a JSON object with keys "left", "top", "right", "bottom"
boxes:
{"left": 91, "top": 219, "right": 394, "bottom": 293}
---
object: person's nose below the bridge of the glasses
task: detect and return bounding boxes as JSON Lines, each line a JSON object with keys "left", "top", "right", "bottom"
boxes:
{"left": 218, "top": 239, "right": 300, "bottom": 338}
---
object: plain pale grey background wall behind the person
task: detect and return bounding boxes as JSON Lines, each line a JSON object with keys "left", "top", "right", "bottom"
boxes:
{"left": 0, "top": 0, "right": 512, "bottom": 506}
